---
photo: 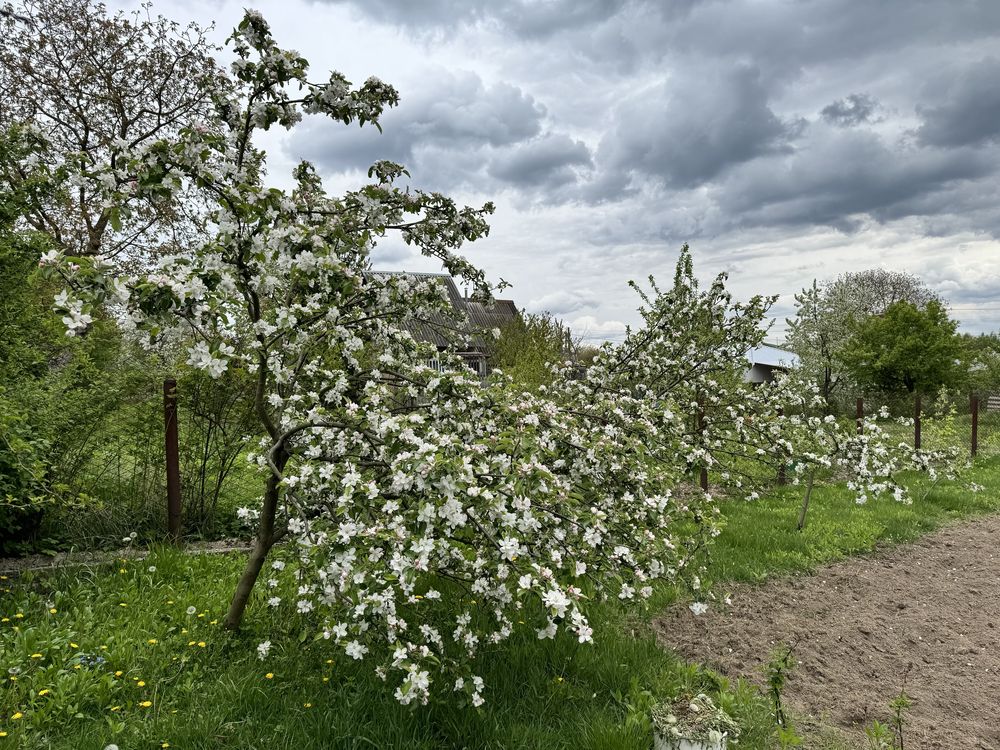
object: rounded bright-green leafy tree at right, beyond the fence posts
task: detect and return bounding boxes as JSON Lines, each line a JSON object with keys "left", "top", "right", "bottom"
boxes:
{"left": 839, "top": 300, "right": 962, "bottom": 393}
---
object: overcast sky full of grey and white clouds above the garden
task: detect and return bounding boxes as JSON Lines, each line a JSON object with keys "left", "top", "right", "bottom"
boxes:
{"left": 133, "top": 0, "right": 1000, "bottom": 340}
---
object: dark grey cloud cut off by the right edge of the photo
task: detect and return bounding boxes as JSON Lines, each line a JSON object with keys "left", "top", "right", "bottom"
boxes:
{"left": 917, "top": 58, "right": 1000, "bottom": 147}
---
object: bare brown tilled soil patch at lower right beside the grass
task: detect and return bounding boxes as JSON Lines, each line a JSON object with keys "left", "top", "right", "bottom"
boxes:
{"left": 656, "top": 517, "right": 1000, "bottom": 750}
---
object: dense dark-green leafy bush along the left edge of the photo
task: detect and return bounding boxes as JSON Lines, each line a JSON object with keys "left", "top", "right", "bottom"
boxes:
{"left": 0, "top": 126, "right": 129, "bottom": 553}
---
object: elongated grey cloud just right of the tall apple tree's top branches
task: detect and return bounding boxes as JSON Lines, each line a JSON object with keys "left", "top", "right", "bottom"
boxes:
{"left": 288, "top": 73, "right": 545, "bottom": 178}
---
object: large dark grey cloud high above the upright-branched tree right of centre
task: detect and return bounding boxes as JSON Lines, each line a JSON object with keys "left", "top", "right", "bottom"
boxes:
{"left": 599, "top": 66, "right": 801, "bottom": 188}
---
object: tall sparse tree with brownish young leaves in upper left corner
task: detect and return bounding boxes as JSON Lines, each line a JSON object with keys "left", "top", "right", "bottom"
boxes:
{"left": 0, "top": 0, "right": 220, "bottom": 261}
